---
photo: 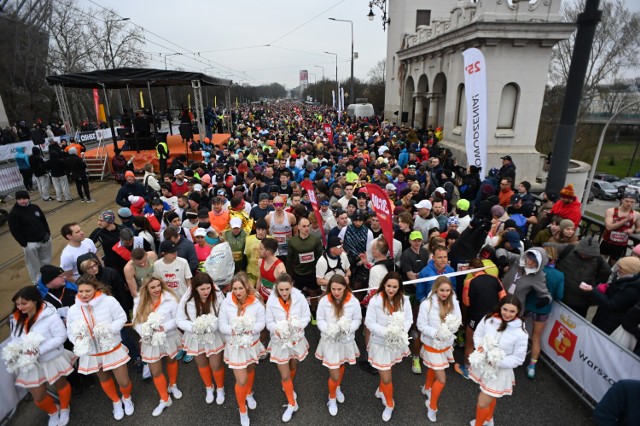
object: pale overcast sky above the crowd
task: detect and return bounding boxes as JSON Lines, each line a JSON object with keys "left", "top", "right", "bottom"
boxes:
{"left": 78, "top": 0, "right": 640, "bottom": 89}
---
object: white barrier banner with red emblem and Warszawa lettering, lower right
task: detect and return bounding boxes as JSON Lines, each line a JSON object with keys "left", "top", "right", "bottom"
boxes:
{"left": 541, "top": 302, "right": 640, "bottom": 401}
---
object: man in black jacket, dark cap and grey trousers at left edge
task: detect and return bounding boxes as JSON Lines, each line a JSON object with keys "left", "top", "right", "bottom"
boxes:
{"left": 9, "top": 191, "right": 52, "bottom": 284}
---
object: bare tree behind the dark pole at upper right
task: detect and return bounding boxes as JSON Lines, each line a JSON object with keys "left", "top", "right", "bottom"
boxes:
{"left": 549, "top": 0, "right": 640, "bottom": 112}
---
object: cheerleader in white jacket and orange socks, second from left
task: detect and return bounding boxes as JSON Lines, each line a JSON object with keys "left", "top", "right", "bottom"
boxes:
{"left": 67, "top": 274, "right": 134, "bottom": 420}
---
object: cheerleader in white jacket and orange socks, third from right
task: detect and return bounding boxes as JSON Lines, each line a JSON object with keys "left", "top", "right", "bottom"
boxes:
{"left": 364, "top": 272, "right": 413, "bottom": 422}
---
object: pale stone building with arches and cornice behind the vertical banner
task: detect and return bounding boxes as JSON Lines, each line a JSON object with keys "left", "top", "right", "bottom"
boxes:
{"left": 384, "top": 0, "right": 575, "bottom": 182}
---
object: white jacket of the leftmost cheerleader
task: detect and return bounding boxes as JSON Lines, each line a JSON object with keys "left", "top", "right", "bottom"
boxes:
{"left": 9, "top": 302, "right": 67, "bottom": 362}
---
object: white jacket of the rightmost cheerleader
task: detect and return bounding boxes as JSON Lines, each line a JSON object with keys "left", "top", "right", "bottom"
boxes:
{"left": 473, "top": 317, "right": 529, "bottom": 368}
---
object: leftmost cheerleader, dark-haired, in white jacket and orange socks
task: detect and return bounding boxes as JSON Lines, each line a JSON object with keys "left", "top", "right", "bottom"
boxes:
{"left": 9, "top": 286, "right": 77, "bottom": 426}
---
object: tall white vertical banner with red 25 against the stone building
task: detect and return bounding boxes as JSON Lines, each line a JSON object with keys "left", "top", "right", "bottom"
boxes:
{"left": 462, "top": 47, "right": 488, "bottom": 179}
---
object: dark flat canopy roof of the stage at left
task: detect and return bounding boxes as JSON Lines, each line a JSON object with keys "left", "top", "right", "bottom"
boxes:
{"left": 47, "top": 68, "right": 233, "bottom": 89}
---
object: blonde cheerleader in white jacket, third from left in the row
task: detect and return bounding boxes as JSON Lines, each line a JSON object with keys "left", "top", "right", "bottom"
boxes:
{"left": 133, "top": 275, "right": 182, "bottom": 417}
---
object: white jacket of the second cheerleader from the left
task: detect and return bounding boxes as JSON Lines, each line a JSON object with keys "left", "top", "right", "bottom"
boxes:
{"left": 67, "top": 293, "right": 127, "bottom": 355}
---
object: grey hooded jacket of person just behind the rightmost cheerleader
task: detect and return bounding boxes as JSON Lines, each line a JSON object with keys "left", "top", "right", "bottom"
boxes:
{"left": 496, "top": 247, "right": 552, "bottom": 306}
